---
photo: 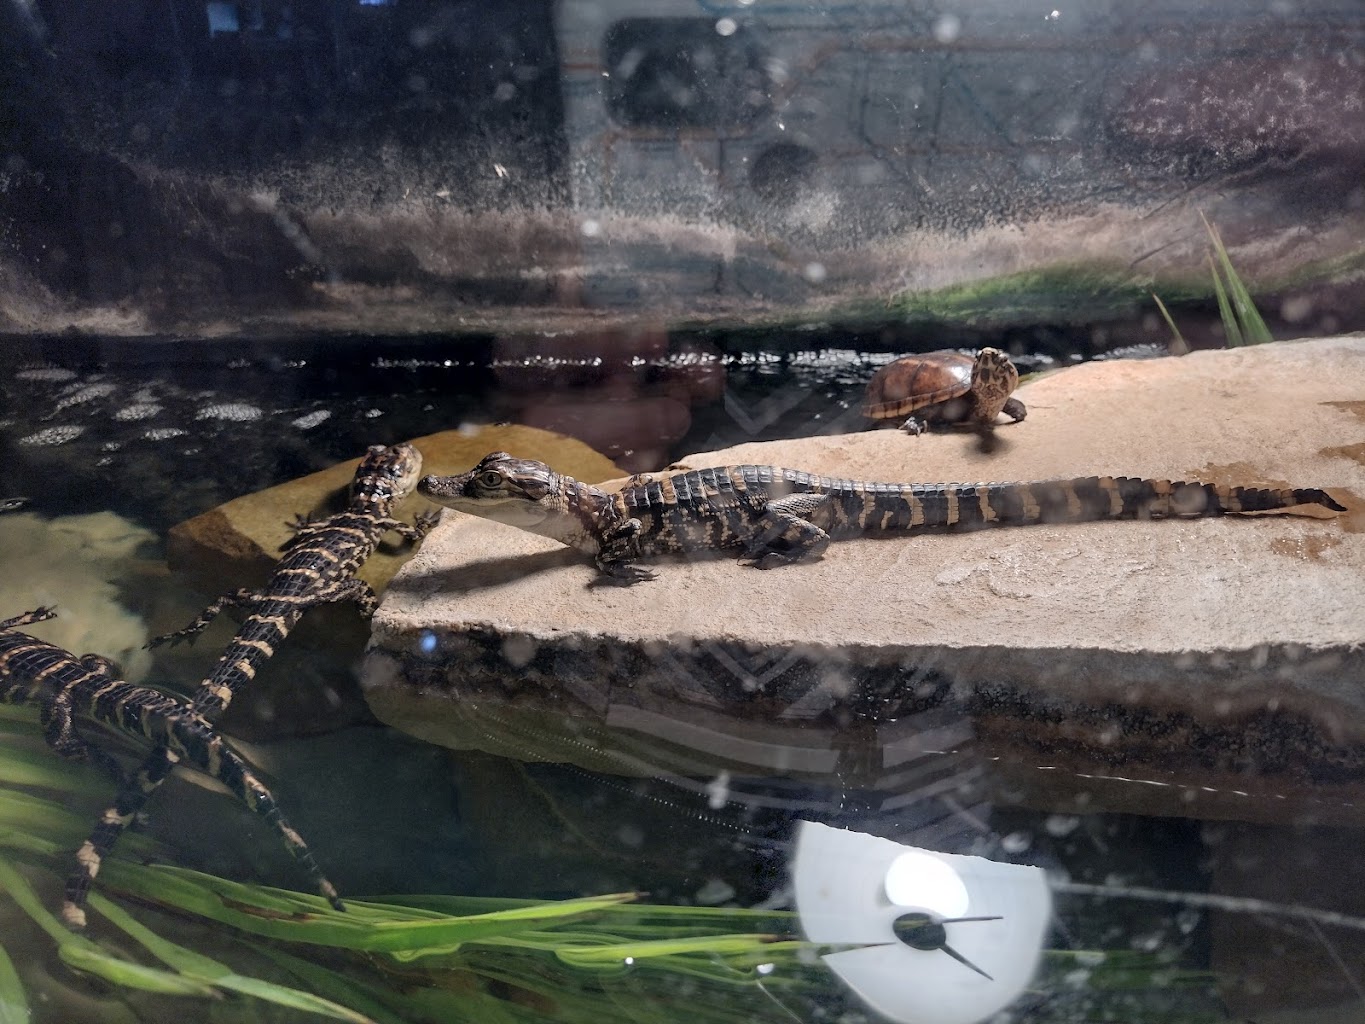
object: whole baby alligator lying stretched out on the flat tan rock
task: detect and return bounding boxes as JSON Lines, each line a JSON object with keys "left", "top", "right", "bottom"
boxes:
{"left": 418, "top": 452, "right": 1346, "bottom": 583}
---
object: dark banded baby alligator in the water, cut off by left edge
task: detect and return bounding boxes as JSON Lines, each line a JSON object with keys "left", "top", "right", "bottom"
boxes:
{"left": 0, "top": 608, "right": 341, "bottom": 928}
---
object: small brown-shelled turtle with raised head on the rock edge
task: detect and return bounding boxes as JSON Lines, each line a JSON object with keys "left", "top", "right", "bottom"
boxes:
{"left": 863, "top": 348, "right": 1028, "bottom": 434}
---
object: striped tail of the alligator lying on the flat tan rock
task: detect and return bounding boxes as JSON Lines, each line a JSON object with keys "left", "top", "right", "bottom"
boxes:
{"left": 854, "top": 477, "right": 1346, "bottom": 530}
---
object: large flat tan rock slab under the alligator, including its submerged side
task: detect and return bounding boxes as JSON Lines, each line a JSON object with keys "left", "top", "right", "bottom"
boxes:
{"left": 366, "top": 336, "right": 1365, "bottom": 818}
